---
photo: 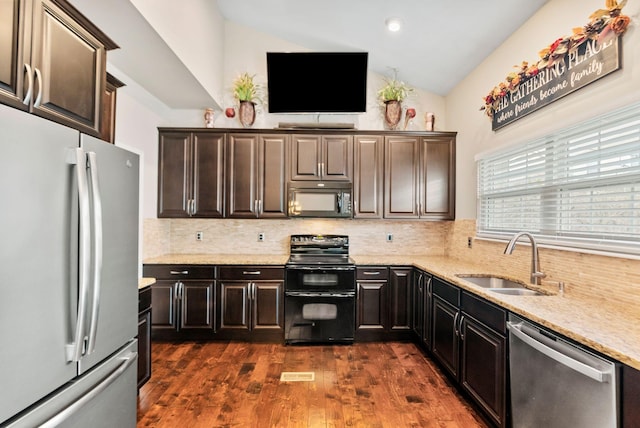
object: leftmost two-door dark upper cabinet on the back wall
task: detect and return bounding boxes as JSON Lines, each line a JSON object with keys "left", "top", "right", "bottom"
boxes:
{"left": 158, "top": 131, "right": 226, "bottom": 218}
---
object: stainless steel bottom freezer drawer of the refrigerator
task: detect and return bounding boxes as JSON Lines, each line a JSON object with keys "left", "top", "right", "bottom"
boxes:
{"left": 2, "top": 340, "right": 138, "bottom": 428}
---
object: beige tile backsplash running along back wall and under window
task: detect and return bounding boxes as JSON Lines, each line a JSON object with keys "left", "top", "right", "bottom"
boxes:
{"left": 143, "top": 218, "right": 640, "bottom": 305}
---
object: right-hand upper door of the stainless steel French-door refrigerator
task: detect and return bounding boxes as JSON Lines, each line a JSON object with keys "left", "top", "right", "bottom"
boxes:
{"left": 80, "top": 135, "right": 139, "bottom": 373}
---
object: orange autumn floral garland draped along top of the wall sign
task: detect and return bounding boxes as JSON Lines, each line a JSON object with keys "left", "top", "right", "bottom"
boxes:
{"left": 480, "top": 0, "right": 630, "bottom": 117}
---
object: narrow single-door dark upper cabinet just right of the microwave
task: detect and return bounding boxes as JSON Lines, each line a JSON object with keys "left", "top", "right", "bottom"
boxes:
{"left": 353, "top": 135, "right": 384, "bottom": 218}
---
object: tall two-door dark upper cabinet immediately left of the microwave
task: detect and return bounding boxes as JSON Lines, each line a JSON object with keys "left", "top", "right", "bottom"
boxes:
{"left": 226, "top": 133, "right": 289, "bottom": 218}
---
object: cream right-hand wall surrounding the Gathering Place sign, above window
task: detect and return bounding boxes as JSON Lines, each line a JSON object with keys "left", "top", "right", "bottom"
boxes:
{"left": 446, "top": 0, "right": 640, "bottom": 219}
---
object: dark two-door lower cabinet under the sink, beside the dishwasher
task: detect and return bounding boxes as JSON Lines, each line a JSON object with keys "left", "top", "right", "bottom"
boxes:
{"left": 431, "top": 277, "right": 507, "bottom": 427}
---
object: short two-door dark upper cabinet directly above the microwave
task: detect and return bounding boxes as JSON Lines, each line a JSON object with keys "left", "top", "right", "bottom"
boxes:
{"left": 291, "top": 134, "right": 353, "bottom": 181}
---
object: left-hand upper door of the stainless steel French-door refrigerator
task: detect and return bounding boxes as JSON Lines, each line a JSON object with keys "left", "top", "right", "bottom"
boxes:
{"left": 0, "top": 105, "right": 79, "bottom": 425}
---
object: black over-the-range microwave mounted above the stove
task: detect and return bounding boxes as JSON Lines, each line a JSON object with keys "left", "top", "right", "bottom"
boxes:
{"left": 288, "top": 181, "right": 353, "bottom": 218}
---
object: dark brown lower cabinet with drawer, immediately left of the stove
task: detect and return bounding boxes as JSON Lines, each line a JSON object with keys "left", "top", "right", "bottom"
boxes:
{"left": 217, "top": 266, "right": 284, "bottom": 342}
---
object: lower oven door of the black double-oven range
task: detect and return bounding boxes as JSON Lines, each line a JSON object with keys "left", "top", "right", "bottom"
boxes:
{"left": 284, "top": 291, "right": 356, "bottom": 344}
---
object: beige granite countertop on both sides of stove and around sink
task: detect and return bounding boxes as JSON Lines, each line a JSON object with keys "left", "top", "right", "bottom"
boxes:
{"left": 144, "top": 254, "right": 640, "bottom": 370}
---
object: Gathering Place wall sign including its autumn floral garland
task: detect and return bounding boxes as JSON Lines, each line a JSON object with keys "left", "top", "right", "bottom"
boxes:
{"left": 481, "top": 0, "right": 629, "bottom": 131}
